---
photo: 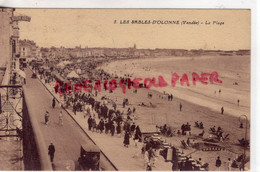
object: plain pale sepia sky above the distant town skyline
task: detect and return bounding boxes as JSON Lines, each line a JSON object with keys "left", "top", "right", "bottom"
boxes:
{"left": 15, "top": 9, "right": 251, "bottom": 50}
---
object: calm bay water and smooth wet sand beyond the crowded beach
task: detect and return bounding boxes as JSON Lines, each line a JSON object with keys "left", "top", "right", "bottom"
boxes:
{"left": 101, "top": 56, "right": 250, "bottom": 118}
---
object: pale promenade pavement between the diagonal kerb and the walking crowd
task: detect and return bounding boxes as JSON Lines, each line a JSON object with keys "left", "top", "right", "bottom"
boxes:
{"left": 34, "top": 68, "right": 172, "bottom": 171}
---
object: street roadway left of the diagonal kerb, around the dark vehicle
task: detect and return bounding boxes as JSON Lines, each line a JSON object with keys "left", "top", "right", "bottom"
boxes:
{"left": 25, "top": 69, "right": 115, "bottom": 171}
